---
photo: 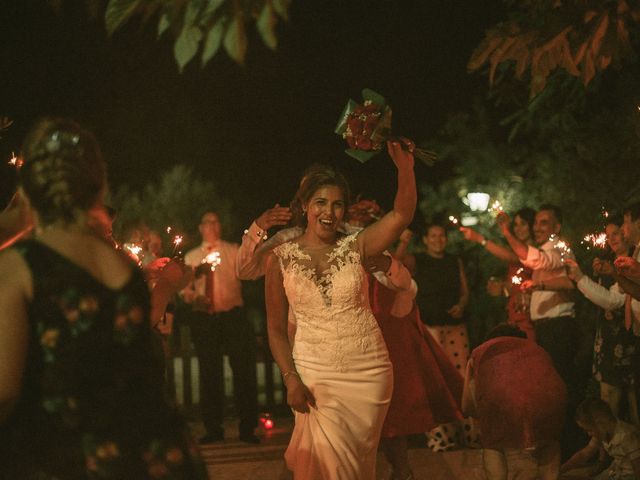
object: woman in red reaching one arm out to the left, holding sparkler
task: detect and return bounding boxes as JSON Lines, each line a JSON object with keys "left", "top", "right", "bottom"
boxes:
{"left": 460, "top": 208, "right": 536, "bottom": 340}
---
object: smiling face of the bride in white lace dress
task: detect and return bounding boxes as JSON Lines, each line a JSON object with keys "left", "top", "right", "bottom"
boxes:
{"left": 304, "top": 185, "right": 346, "bottom": 241}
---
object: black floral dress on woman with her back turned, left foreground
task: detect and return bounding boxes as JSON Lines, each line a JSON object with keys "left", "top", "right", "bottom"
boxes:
{"left": 0, "top": 240, "right": 206, "bottom": 480}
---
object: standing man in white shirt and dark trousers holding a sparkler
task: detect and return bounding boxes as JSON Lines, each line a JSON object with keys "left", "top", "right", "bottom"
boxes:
{"left": 182, "top": 212, "right": 259, "bottom": 443}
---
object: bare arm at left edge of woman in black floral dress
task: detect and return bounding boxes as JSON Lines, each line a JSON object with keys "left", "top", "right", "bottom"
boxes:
{"left": 0, "top": 251, "right": 31, "bottom": 425}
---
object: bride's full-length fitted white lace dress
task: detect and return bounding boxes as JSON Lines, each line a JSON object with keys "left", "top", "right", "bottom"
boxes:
{"left": 274, "top": 234, "right": 393, "bottom": 480}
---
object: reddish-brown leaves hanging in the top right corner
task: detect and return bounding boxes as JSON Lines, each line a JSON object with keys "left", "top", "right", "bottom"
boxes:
{"left": 468, "top": 0, "right": 640, "bottom": 98}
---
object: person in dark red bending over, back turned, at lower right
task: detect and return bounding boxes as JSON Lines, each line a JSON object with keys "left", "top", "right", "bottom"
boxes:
{"left": 462, "top": 324, "right": 567, "bottom": 480}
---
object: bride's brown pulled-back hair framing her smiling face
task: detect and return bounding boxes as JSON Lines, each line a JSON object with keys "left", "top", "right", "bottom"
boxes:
{"left": 290, "top": 164, "right": 351, "bottom": 226}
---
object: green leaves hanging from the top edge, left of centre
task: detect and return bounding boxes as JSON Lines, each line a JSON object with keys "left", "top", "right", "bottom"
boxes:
{"left": 105, "top": 0, "right": 291, "bottom": 71}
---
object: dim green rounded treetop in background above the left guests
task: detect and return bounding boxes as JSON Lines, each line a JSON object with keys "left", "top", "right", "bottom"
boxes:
{"left": 110, "top": 165, "right": 233, "bottom": 249}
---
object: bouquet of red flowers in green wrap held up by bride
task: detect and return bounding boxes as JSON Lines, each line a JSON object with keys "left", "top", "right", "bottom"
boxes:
{"left": 335, "top": 88, "right": 437, "bottom": 165}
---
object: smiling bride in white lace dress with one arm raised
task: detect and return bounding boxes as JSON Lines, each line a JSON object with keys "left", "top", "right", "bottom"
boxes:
{"left": 265, "top": 141, "right": 417, "bottom": 480}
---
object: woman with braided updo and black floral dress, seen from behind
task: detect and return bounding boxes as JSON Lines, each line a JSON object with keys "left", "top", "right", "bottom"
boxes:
{"left": 0, "top": 119, "right": 206, "bottom": 480}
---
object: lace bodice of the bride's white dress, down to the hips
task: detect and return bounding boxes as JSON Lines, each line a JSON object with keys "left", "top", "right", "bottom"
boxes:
{"left": 274, "top": 233, "right": 379, "bottom": 371}
